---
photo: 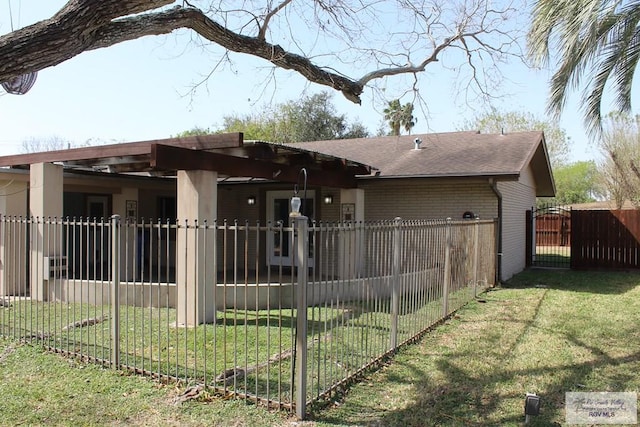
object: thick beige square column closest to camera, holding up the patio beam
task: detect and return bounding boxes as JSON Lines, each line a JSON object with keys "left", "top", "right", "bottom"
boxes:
{"left": 176, "top": 171, "right": 218, "bottom": 326}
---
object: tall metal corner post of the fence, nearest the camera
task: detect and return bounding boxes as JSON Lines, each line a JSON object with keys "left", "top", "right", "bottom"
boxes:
{"left": 293, "top": 216, "right": 309, "bottom": 420}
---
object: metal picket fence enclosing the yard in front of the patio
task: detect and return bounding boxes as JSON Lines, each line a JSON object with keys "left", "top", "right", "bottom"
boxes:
{"left": 0, "top": 217, "right": 497, "bottom": 418}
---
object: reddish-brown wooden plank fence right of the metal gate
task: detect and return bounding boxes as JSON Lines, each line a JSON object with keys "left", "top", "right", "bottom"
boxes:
{"left": 571, "top": 210, "right": 640, "bottom": 269}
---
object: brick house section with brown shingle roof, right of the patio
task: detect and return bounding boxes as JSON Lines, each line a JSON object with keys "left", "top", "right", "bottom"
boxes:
{"left": 296, "top": 132, "right": 555, "bottom": 280}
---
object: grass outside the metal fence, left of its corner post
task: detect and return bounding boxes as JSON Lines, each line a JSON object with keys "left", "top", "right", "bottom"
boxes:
{"left": 0, "top": 339, "right": 286, "bottom": 426}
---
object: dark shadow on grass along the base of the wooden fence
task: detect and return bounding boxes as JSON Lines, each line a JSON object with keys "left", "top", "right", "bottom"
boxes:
{"left": 502, "top": 268, "right": 640, "bottom": 294}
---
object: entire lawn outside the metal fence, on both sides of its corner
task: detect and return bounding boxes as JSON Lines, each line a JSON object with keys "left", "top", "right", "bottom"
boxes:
{"left": 0, "top": 271, "right": 640, "bottom": 426}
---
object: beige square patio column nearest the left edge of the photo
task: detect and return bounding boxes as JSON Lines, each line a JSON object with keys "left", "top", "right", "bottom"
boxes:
{"left": 29, "top": 163, "right": 64, "bottom": 301}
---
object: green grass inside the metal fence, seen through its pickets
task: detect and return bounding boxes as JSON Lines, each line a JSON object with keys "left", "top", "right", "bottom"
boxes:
{"left": 0, "top": 288, "right": 472, "bottom": 404}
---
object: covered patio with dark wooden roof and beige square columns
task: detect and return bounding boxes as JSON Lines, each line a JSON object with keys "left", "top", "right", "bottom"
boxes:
{"left": 0, "top": 133, "right": 371, "bottom": 324}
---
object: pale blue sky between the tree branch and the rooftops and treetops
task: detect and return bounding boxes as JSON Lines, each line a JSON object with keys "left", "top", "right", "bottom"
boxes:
{"left": 0, "top": 0, "right": 612, "bottom": 161}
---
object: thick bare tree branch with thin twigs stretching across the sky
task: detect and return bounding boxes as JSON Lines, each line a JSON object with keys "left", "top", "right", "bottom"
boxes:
{"left": 0, "top": 0, "right": 514, "bottom": 103}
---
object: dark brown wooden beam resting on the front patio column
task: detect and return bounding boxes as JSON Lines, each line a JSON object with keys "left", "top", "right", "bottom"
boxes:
{"left": 150, "top": 144, "right": 356, "bottom": 188}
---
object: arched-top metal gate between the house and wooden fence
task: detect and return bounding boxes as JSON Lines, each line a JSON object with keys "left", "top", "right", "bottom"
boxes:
{"left": 527, "top": 205, "right": 571, "bottom": 268}
